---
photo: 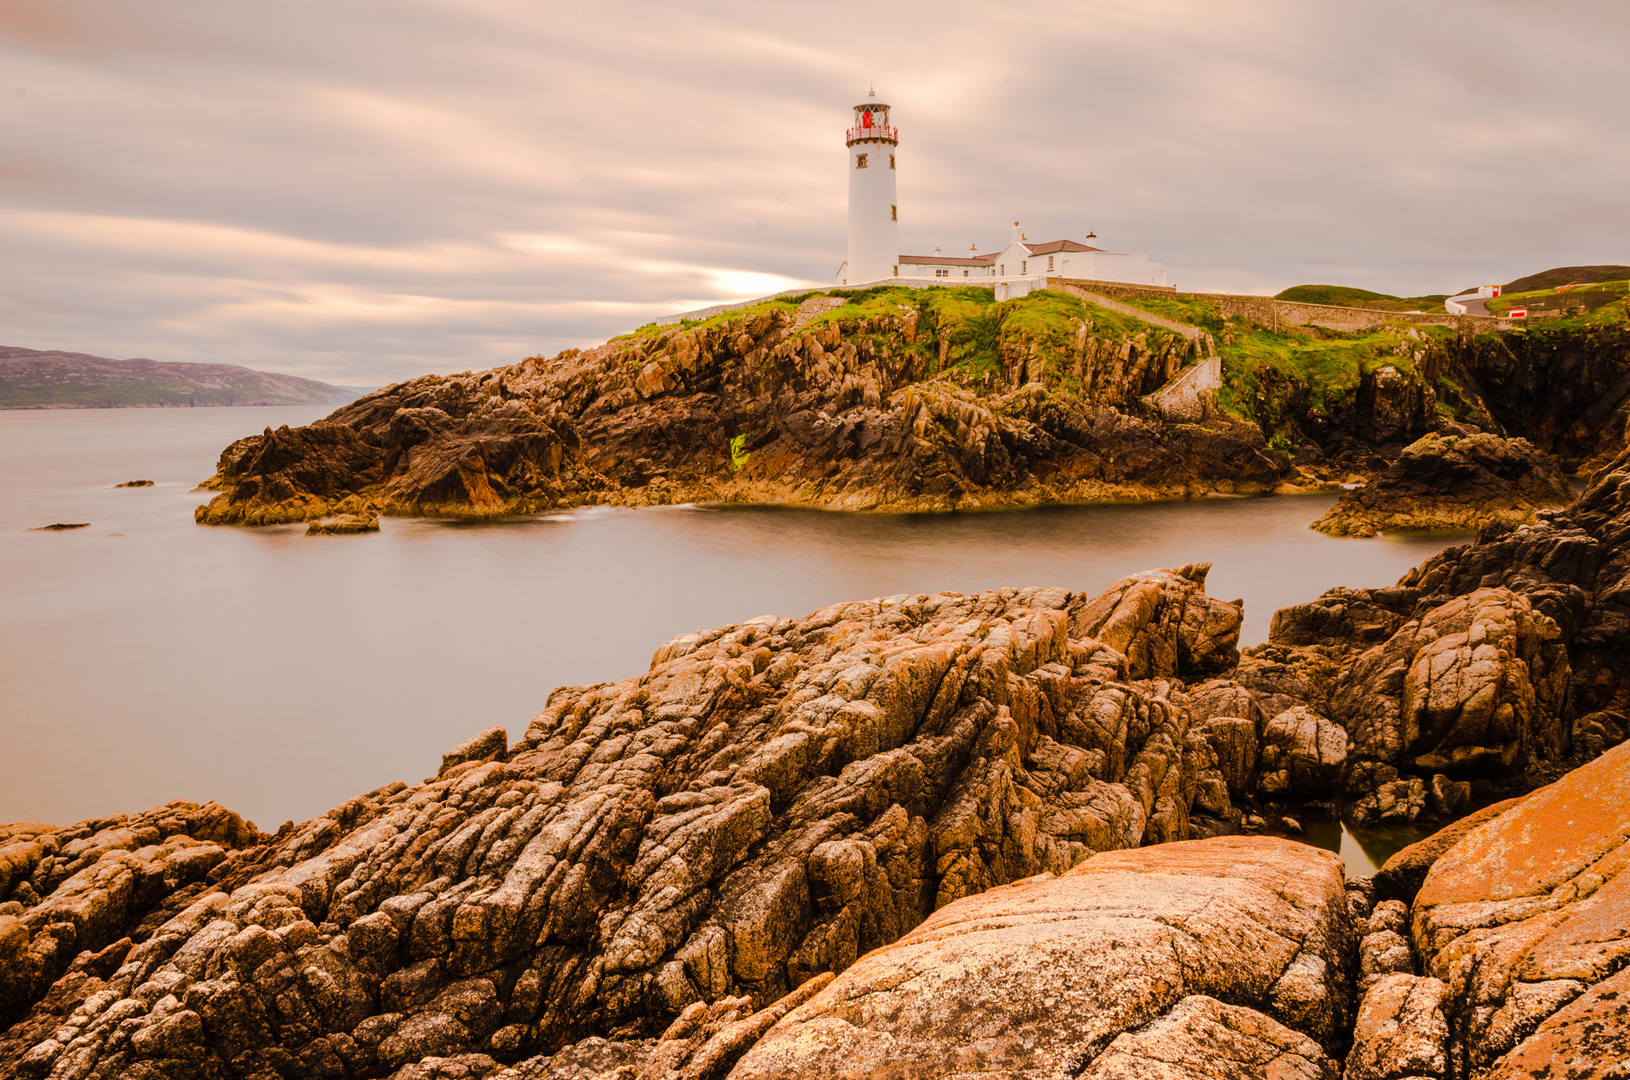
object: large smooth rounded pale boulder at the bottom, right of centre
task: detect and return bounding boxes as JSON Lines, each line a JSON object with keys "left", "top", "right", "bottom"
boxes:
{"left": 730, "top": 837, "right": 1353, "bottom": 1080}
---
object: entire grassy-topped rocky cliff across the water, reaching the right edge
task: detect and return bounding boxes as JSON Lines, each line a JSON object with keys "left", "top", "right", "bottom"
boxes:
{"left": 187, "top": 288, "right": 1630, "bottom": 525}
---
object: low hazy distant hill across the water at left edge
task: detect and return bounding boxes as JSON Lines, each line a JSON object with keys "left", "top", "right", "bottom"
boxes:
{"left": 0, "top": 345, "right": 357, "bottom": 409}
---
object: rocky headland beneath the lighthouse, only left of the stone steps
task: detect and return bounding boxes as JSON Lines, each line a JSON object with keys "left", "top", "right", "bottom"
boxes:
{"left": 199, "top": 288, "right": 1289, "bottom": 525}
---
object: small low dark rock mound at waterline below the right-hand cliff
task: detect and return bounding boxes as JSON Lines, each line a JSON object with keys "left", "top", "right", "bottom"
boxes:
{"left": 1312, "top": 433, "right": 1575, "bottom": 536}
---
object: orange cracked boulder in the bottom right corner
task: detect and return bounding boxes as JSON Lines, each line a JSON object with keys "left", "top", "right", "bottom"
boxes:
{"left": 1412, "top": 746, "right": 1630, "bottom": 1077}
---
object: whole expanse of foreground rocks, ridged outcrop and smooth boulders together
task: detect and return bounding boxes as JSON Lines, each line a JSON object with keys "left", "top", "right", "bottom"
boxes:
{"left": 0, "top": 553, "right": 1630, "bottom": 1080}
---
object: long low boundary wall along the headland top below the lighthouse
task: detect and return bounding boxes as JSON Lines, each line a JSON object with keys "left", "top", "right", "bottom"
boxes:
{"left": 645, "top": 275, "right": 1522, "bottom": 334}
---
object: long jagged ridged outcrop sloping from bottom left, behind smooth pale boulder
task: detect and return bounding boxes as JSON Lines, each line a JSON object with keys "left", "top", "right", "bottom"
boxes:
{"left": 0, "top": 579, "right": 1258, "bottom": 1075}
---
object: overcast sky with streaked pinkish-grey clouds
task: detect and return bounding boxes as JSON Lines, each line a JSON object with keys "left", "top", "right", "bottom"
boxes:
{"left": 0, "top": 0, "right": 1630, "bottom": 386}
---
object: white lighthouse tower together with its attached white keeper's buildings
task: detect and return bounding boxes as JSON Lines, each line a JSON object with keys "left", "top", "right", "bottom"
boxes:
{"left": 838, "top": 91, "right": 1165, "bottom": 295}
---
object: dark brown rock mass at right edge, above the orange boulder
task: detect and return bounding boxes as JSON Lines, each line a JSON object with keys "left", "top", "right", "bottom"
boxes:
{"left": 1219, "top": 443, "right": 1630, "bottom": 821}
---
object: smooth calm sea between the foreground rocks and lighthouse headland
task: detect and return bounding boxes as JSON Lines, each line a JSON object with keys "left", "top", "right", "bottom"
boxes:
{"left": 0, "top": 407, "right": 1464, "bottom": 845}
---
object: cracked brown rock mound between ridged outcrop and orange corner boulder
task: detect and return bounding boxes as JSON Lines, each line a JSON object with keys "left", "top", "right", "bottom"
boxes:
{"left": 1236, "top": 583, "right": 1576, "bottom": 821}
